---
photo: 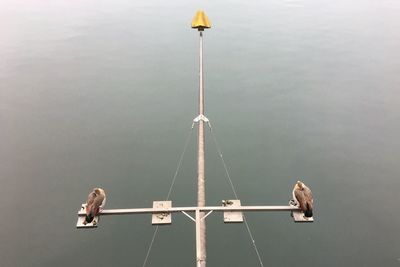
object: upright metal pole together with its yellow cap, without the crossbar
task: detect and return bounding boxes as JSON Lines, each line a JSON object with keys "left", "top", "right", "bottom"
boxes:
{"left": 192, "top": 10, "right": 211, "bottom": 267}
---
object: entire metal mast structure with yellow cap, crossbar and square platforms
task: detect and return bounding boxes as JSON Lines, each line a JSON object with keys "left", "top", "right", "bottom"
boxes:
{"left": 76, "top": 10, "right": 314, "bottom": 267}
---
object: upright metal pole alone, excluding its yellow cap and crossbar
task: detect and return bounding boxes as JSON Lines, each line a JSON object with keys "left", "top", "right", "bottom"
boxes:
{"left": 196, "top": 31, "right": 206, "bottom": 267}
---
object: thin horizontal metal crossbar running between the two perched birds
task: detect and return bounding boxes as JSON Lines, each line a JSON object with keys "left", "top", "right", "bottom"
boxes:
{"left": 78, "top": 206, "right": 300, "bottom": 216}
